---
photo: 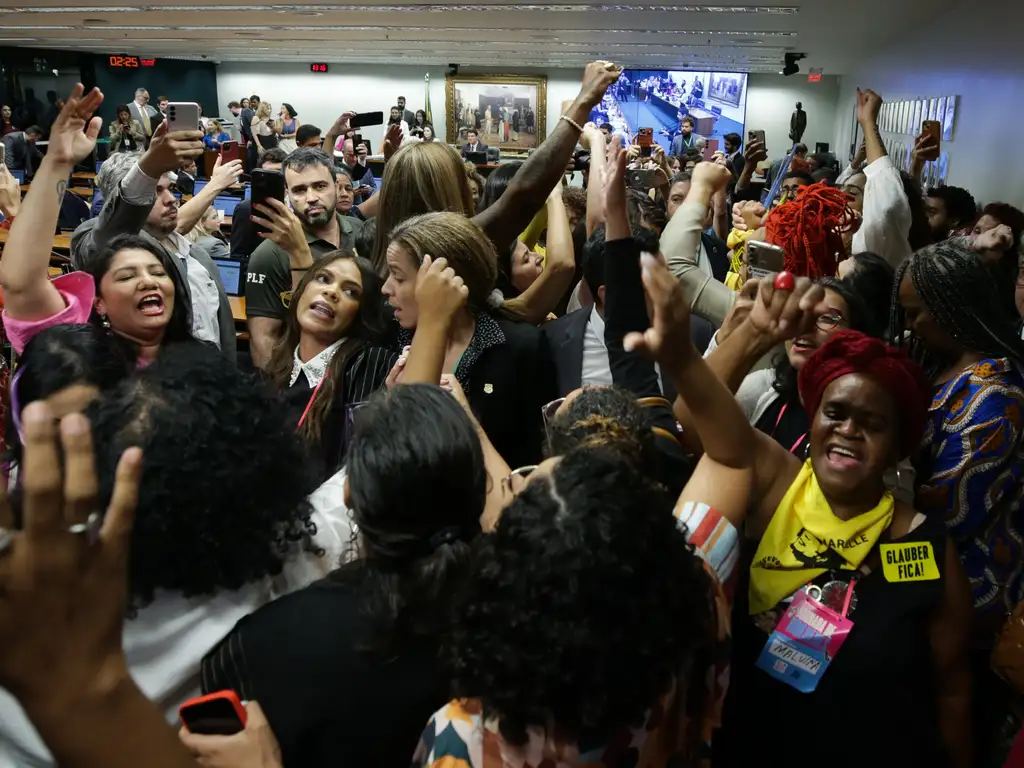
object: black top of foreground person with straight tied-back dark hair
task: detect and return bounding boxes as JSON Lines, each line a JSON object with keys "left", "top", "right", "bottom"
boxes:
{"left": 203, "top": 572, "right": 449, "bottom": 768}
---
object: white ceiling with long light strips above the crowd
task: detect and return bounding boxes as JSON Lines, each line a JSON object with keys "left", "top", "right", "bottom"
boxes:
{"left": 0, "top": 0, "right": 955, "bottom": 74}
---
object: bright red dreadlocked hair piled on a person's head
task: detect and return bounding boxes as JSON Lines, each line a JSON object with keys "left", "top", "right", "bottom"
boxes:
{"left": 765, "top": 181, "right": 855, "bottom": 280}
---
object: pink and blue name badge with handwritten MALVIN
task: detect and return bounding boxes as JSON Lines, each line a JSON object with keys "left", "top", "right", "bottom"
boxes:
{"left": 756, "top": 586, "right": 853, "bottom": 693}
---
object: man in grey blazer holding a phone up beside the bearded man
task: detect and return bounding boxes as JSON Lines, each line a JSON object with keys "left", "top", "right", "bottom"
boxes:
{"left": 71, "top": 124, "right": 236, "bottom": 361}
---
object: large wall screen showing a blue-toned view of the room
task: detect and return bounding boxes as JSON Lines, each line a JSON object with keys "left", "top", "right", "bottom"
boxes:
{"left": 590, "top": 70, "right": 746, "bottom": 152}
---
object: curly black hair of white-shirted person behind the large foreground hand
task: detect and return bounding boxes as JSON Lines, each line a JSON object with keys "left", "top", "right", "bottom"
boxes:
{"left": 86, "top": 343, "right": 322, "bottom": 606}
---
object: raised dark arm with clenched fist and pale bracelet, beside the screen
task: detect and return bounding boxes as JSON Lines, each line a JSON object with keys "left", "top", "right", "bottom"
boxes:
{"left": 473, "top": 61, "right": 621, "bottom": 250}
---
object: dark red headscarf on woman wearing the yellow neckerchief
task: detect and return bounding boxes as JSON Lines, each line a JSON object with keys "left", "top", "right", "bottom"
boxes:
{"left": 797, "top": 331, "right": 932, "bottom": 458}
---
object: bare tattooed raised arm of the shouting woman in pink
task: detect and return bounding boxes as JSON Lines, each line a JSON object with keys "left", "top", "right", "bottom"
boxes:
{"left": 0, "top": 83, "right": 103, "bottom": 321}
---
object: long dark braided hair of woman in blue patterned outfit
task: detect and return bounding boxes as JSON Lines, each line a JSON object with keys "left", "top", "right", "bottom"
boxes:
{"left": 889, "top": 241, "right": 1024, "bottom": 373}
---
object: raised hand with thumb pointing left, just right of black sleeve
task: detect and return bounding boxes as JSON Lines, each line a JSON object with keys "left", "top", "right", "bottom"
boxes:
{"left": 623, "top": 253, "right": 697, "bottom": 372}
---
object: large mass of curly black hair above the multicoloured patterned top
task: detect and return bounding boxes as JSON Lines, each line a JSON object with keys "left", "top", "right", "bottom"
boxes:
{"left": 444, "top": 449, "right": 714, "bottom": 744}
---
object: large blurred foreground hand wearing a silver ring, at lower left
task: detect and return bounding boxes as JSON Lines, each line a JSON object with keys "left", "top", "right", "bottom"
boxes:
{"left": 0, "top": 405, "right": 196, "bottom": 768}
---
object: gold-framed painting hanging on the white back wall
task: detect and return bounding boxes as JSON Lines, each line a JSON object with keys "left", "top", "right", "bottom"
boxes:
{"left": 444, "top": 74, "right": 548, "bottom": 157}
